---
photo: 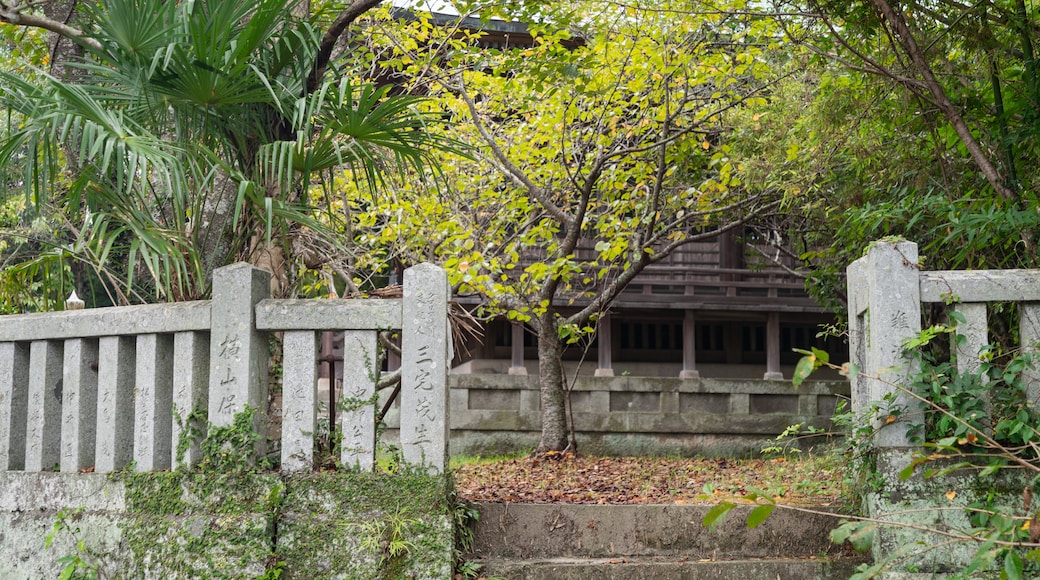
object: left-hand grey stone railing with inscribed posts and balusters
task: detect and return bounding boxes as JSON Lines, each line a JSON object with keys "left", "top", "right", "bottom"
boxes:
{"left": 0, "top": 264, "right": 451, "bottom": 473}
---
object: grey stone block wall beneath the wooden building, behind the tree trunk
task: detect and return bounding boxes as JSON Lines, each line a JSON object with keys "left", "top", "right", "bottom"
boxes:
{"left": 378, "top": 374, "right": 849, "bottom": 456}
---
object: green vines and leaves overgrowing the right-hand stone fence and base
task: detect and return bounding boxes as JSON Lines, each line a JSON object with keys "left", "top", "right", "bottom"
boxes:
{"left": 782, "top": 318, "right": 1040, "bottom": 579}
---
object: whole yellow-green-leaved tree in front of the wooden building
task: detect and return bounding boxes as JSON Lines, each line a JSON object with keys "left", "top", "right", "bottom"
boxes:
{"left": 341, "top": 1, "right": 780, "bottom": 451}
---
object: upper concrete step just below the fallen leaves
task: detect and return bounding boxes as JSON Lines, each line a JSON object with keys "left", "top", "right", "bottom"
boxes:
{"left": 469, "top": 503, "right": 850, "bottom": 562}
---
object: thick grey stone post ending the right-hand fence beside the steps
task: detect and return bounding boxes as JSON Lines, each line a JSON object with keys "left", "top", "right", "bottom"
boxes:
{"left": 849, "top": 241, "right": 920, "bottom": 448}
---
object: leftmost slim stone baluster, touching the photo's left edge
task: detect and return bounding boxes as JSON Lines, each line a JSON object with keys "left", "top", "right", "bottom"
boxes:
{"left": 0, "top": 342, "right": 29, "bottom": 471}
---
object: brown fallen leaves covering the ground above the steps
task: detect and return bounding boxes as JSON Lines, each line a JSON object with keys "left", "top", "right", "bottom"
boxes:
{"left": 454, "top": 454, "right": 844, "bottom": 506}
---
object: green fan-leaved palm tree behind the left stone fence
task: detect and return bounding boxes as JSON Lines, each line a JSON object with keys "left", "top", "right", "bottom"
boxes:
{"left": 0, "top": 0, "right": 453, "bottom": 309}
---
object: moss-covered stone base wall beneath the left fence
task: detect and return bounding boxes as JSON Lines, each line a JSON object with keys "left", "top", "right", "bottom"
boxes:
{"left": 0, "top": 471, "right": 453, "bottom": 580}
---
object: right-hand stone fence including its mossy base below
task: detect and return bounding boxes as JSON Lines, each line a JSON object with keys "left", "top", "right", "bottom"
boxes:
{"left": 848, "top": 240, "right": 1040, "bottom": 578}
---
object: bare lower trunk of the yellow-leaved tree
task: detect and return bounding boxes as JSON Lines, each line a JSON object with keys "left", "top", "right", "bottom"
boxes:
{"left": 537, "top": 312, "right": 569, "bottom": 452}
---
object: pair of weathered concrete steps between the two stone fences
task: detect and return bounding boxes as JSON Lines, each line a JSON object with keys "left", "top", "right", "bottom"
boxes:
{"left": 468, "top": 503, "right": 865, "bottom": 580}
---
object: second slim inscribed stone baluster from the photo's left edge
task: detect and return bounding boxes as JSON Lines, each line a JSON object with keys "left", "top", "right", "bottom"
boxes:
{"left": 25, "top": 340, "right": 62, "bottom": 471}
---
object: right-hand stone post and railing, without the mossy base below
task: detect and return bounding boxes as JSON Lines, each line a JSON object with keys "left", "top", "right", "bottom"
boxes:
{"left": 848, "top": 241, "right": 1040, "bottom": 448}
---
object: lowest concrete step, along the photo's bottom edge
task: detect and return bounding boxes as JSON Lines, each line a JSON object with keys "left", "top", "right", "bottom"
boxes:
{"left": 476, "top": 557, "right": 865, "bottom": 580}
